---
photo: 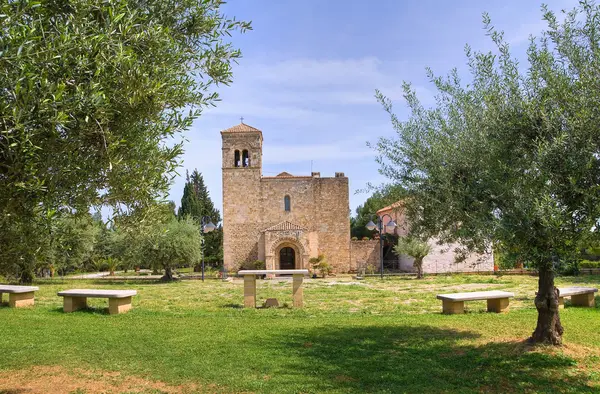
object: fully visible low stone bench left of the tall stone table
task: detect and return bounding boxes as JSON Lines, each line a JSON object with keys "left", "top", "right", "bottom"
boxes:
{"left": 58, "top": 289, "right": 137, "bottom": 315}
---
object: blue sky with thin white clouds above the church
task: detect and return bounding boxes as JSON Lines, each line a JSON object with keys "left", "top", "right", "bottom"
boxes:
{"left": 168, "top": 0, "right": 577, "bottom": 219}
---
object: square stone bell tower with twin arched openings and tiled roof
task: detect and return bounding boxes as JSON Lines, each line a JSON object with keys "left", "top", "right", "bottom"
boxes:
{"left": 221, "top": 122, "right": 263, "bottom": 270}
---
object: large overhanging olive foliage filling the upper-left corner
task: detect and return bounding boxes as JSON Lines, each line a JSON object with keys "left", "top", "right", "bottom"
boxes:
{"left": 0, "top": 0, "right": 250, "bottom": 281}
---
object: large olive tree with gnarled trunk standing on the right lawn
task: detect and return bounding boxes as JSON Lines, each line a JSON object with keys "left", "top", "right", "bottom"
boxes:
{"left": 376, "top": 2, "right": 600, "bottom": 345}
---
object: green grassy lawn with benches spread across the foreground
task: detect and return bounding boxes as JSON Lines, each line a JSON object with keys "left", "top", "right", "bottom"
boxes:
{"left": 0, "top": 276, "right": 600, "bottom": 393}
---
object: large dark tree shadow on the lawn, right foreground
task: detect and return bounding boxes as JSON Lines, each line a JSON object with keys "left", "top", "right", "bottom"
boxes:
{"left": 267, "top": 326, "right": 598, "bottom": 393}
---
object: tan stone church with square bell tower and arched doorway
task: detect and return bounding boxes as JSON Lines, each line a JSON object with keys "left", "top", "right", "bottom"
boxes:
{"left": 221, "top": 123, "right": 351, "bottom": 272}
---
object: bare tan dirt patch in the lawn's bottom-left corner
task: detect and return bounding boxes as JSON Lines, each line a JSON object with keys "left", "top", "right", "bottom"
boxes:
{"left": 0, "top": 366, "right": 222, "bottom": 394}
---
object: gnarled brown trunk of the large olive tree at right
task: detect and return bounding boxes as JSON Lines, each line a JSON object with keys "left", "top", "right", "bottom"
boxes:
{"left": 529, "top": 266, "right": 563, "bottom": 345}
